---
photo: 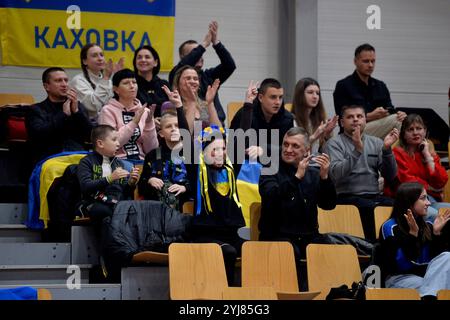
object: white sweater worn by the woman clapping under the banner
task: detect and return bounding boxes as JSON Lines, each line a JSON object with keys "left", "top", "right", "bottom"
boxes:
{"left": 69, "top": 71, "right": 113, "bottom": 119}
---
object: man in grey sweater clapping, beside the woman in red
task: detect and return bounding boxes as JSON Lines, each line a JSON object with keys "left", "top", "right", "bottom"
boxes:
{"left": 325, "top": 105, "right": 399, "bottom": 240}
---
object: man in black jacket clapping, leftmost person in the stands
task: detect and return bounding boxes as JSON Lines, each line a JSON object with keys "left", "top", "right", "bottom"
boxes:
{"left": 26, "top": 67, "right": 92, "bottom": 164}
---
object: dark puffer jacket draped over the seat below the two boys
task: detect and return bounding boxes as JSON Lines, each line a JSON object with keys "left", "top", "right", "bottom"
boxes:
{"left": 102, "top": 200, "right": 191, "bottom": 267}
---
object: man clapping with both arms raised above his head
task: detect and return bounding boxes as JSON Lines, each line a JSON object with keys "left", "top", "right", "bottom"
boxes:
{"left": 169, "top": 21, "right": 236, "bottom": 123}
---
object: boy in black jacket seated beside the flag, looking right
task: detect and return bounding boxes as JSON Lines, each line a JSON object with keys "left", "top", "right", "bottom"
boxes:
{"left": 77, "top": 125, "right": 139, "bottom": 222}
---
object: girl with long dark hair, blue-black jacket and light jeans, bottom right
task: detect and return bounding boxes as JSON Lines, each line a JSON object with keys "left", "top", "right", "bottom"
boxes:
{"left": 380, "top": 182, "right": 450, "bottom": 297}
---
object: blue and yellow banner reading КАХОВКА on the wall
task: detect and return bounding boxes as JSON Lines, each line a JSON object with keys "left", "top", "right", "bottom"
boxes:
{"left": 0, "top": 0, "right": 175, "bottom": 71}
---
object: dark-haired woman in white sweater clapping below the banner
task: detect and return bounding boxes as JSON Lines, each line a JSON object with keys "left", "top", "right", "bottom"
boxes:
{"left": 69, "top": 43, "right": 123, "bottom": 121}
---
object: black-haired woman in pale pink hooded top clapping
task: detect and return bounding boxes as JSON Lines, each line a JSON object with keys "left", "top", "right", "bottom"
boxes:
{"left": 99, "top": 69, "right": 158, "bottom": 163}
